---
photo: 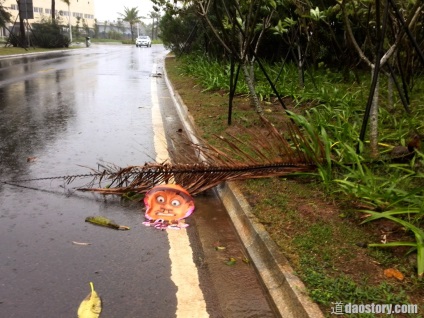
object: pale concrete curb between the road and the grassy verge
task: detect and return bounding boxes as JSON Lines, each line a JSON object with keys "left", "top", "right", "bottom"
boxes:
{"left": 163, "top": 57, "right": 324, "bottom": 318}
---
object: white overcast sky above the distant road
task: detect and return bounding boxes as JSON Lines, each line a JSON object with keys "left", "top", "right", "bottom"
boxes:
{"left": 94, "top": 0, "right": 153, "bottom": 21}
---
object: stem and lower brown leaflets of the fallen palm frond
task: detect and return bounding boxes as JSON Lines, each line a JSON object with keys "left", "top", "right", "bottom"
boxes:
{"left": 79, "top": 163, "right": 315, "bottom": 195}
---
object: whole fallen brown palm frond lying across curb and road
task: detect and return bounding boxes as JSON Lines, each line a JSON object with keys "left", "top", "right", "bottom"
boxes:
{"left": 74, "top": 119, "right": 324, "bottom": 195}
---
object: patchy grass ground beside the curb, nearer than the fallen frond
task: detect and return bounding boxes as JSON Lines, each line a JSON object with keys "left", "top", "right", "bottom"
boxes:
{"left": 242, "top": 178, "right": 422, "bottom": 317}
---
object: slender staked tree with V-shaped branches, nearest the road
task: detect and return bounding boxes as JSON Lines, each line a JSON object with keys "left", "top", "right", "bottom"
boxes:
{"left": 152, "top": 0, "right": 292, "bottom": 117}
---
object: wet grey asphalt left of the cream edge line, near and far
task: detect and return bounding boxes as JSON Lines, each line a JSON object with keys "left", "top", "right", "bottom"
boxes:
{"left": 0, "top": 46, "right": 176, "bottom": 317}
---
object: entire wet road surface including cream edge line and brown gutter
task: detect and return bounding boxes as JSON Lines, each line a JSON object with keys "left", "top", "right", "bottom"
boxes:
{"left": 0, "top": 45, "right": 275, "bottom": 317}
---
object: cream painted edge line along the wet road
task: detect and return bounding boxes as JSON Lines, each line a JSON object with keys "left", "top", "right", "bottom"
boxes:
{"left": 150, "top": 63, "right": 209, "bottom": 318}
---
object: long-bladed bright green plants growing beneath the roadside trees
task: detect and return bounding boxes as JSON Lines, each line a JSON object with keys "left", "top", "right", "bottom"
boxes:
{"left": 176, "top": 54, "right": 424, "bottom": 277}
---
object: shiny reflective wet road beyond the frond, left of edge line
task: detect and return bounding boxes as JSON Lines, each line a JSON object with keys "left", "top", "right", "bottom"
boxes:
{"left": 0, "top": 47, "right": 156, "bottom": 177}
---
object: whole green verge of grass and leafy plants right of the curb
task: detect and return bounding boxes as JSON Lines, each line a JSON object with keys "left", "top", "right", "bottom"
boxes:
{"left": 167, "top": 57, "right": 424, "bottom": 317}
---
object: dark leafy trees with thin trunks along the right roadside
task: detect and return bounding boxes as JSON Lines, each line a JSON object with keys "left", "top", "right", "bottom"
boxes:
{"left": 152, "top": 0, "right": 424, "bottom": 156}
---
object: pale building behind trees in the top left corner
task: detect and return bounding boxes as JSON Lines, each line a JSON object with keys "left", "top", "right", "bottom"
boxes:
{"left": 0, "top": 0, "right": 95, "bottom": 36}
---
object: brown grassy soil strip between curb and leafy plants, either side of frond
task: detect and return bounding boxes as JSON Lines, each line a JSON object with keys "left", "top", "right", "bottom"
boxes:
{"left": 166, "top": 57, "right": 424, "bottom": 317}
